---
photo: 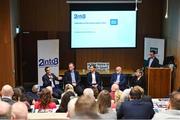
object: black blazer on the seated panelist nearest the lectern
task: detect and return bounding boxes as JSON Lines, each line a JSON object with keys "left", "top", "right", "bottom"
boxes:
{"left": 130, "top": 76, "right": 145, "bottom": 88}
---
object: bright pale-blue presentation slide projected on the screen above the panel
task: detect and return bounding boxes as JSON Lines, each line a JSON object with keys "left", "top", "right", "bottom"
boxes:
{"left": 71, "top": 11, "right": 136, "bottom": 48}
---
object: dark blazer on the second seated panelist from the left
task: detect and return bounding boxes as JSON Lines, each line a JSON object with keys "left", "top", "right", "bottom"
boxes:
{"left": 63, "top": 70, "right": 81, "bottom": 85}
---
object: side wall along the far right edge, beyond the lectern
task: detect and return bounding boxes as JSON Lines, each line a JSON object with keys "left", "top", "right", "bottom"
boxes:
{"left": 164, "top": 0, "right": 180, "bottom": 89}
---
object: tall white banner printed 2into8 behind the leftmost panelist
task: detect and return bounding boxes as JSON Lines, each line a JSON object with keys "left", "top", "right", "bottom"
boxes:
{"left": 37, "top": 39, "right": 59, "bottom": 85}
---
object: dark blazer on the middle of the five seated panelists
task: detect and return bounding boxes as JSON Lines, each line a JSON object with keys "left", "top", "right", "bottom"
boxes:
{"left": 87, "top": 72, "right": 103, "bottom": 90}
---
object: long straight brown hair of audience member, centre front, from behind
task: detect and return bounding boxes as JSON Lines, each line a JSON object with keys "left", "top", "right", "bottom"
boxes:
{"left": 97, "top": 90, "right": 111, "bottom": 114}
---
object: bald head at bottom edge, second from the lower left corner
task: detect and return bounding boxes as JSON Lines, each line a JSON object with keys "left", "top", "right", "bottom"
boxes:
{"left": 11, "top": 102, "right": 28, "bottom": 120}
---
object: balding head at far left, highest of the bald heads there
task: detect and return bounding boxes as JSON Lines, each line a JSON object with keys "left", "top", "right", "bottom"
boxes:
{"left": 1, "top": 84, "right": 14, "bottom": 98}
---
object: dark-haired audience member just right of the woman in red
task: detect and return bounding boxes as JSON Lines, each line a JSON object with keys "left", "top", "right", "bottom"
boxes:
{"left": 56, "top": 91, "right": 75, "bottom": 112}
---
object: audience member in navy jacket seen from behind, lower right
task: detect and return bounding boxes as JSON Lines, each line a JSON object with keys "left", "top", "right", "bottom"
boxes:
{"left": 117, "top": 86, "right": 154, "bottom": 119}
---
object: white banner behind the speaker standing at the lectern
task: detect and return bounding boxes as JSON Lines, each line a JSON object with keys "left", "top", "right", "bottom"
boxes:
{"left": 144, "top": 38, "right": 164, "bottom": 65}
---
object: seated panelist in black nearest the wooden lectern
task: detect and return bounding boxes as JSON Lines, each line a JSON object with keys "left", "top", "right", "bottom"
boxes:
{"left": 130, "top": 69, "right": 145, "bottom": 88}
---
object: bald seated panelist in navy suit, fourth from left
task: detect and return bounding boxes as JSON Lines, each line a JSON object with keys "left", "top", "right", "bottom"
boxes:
{"left": 110, "top": 66, "right": 127, "bottom": 90}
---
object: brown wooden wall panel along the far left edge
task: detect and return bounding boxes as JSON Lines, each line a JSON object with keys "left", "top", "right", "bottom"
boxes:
{"left": 0, "top": 0, "right": 15, "bottom": 89}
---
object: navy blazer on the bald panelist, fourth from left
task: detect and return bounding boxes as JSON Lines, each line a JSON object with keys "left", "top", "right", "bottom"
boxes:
{"left": 110, "top": 73, "right": 127, "bottom": 90}
